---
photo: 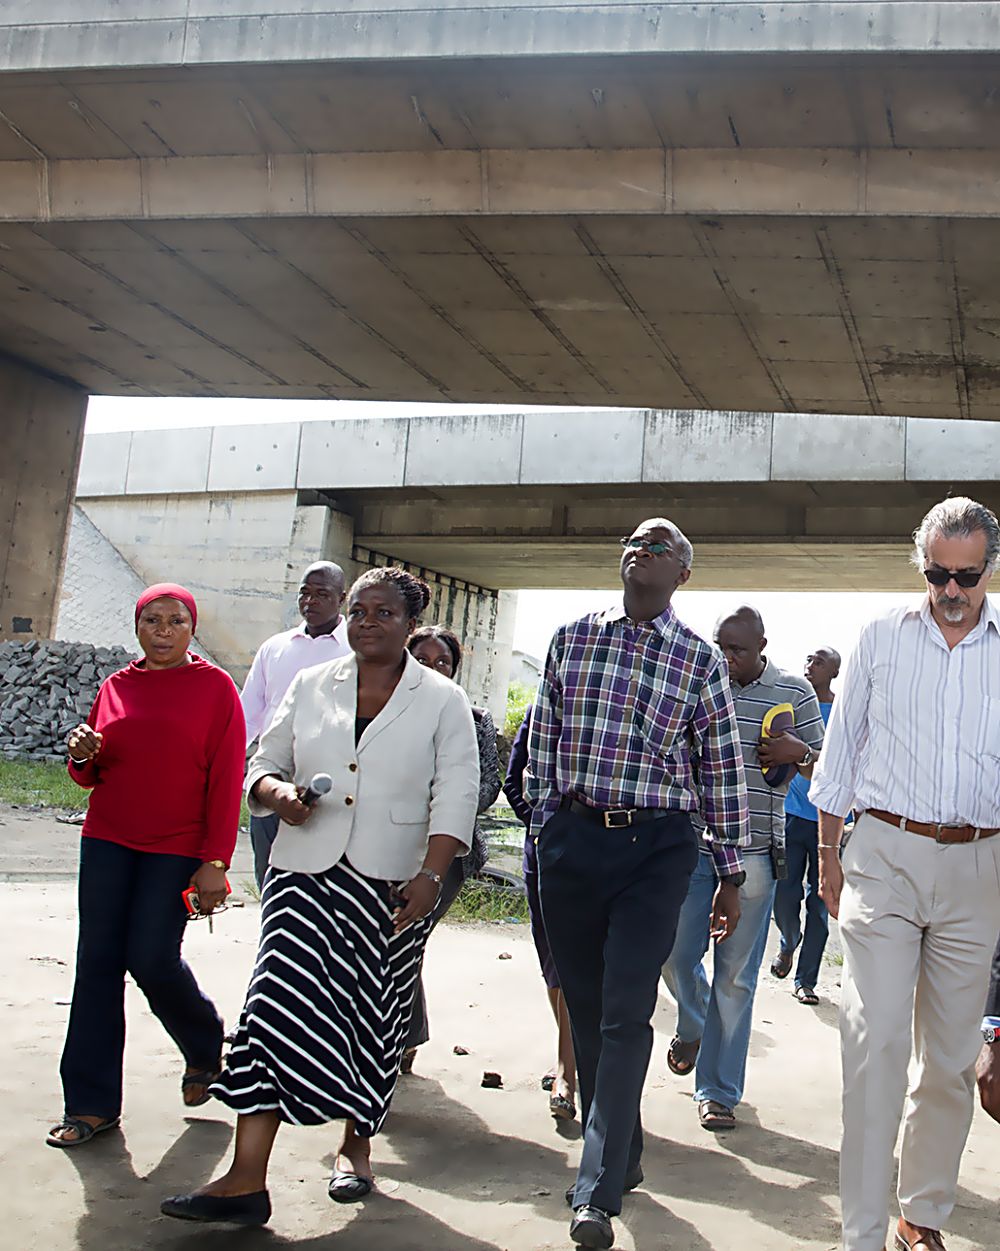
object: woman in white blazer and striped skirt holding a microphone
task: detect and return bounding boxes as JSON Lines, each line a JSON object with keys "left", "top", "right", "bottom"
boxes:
{"left": 160, "top": 567, "right": 479, "bottom": 1226}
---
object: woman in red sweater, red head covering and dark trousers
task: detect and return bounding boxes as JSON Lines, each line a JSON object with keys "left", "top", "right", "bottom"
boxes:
{"left": 46, "top": 583, "right": 245, "bottom": 1147}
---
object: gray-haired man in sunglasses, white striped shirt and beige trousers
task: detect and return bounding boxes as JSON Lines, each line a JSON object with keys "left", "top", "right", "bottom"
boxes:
{"left": 810, "top": 498, "right": 1000, "bottom": 1251}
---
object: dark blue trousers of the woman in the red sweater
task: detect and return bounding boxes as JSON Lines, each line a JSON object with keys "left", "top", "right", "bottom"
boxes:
{"left": 60, "top": 838, "right": 223, "bottom": 1117}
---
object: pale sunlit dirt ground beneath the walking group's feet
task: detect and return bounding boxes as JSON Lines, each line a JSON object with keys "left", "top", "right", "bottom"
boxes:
{"left": 0, "top": 809, "right": 1000, "bottom": 1251}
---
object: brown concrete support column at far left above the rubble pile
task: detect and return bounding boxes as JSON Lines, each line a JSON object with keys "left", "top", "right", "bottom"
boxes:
{"left": 0, "top": 358, "right": 86, "bottom": 639}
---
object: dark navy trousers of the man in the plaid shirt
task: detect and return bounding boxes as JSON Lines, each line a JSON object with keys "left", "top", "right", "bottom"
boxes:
{"left": 538, "top": 809, "right": 698, "bottom": 1216}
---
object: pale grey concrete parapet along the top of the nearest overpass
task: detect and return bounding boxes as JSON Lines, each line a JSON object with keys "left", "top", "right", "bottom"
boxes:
{"left": 0, "top": 0, "right": 1000, "bottom": 70}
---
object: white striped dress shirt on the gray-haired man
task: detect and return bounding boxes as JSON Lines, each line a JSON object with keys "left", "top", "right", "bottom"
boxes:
{"left": 809, "top": 598, "right": 1000, "bottom": 828}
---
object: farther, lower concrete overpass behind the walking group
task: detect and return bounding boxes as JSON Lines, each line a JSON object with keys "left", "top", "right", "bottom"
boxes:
{"left": 70, "top": 409, "right": 1000, "bottom": 704}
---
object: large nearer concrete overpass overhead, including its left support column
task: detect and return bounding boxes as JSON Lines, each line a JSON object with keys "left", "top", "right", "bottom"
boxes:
{"left": 0, "top": 0, "right": 1000, "bottom": 650}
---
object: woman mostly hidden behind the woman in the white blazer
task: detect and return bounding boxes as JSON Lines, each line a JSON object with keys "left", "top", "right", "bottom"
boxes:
{"left": 401, "top": 626, "right": 501, "bottom": 1073}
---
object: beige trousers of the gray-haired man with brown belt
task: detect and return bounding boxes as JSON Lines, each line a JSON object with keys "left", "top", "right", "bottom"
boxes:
{"left": 840, "top": 816, "right": 1000, "bottom": 1251}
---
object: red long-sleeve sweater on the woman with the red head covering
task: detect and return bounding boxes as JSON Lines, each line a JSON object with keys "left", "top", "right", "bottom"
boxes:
{"left": 69, "top": 656, "right": 247, "bottom": 864}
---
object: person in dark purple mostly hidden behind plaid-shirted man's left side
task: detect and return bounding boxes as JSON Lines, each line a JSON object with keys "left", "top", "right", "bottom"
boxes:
{"left": 503, "top": 708, "right": 577, "bottom": 1121}
